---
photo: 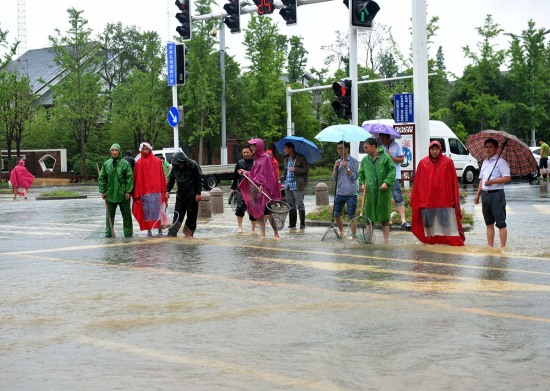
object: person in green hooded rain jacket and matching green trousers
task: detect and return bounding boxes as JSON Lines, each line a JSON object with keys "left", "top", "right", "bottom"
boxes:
{"left": 98, "top": 144, "right": 134, "bottom": 238}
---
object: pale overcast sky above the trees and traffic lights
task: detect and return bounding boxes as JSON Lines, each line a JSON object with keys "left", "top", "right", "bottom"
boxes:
{"left": 0, "top": 0, "right": 550, "bottom": 76}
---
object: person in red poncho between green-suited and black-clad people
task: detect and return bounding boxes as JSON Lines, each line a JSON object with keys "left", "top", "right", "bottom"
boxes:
{"left": 132, "top": 142, "right": 166, "bottom": 236}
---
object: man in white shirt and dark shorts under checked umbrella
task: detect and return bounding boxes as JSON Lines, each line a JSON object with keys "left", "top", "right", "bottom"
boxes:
{"left": 474, "top": 138, "right": 512, "bottom": 247}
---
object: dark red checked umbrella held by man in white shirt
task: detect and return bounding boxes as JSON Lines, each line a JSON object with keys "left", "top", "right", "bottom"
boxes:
{"left": 466, "top": 130, "right": 537, "bottom": 175}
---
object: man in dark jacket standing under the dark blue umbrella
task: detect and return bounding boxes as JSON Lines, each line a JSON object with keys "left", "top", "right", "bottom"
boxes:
{"left": 283, "top": 141, "right": 309, "bottom": 229}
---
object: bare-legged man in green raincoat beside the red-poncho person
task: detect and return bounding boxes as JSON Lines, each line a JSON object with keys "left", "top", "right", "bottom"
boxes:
{"left": 359, "top": 137, "right": 395, "bottom": 243}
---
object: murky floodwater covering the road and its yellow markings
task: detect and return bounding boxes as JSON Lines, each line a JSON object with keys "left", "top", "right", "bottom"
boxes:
{"left": 0, "top": 182, "right": 550, "bottom": 390}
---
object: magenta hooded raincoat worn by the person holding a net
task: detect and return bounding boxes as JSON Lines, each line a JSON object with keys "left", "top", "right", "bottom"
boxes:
{"left": 239, "top": 138, "right": 282, "bottom": 219}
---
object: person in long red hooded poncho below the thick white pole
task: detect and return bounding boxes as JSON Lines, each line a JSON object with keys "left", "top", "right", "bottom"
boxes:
{"left": 411, "top": 140, "right": 465, "bottom": 246}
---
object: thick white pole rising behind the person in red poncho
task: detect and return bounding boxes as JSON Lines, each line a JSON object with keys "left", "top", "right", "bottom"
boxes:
{"left": 412, "top": 0, "right": 430, "bottom": 166}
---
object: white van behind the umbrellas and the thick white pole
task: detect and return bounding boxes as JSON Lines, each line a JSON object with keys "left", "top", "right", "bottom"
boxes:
{"left": 359, "top": 119, "right": 479, "bottom": 183}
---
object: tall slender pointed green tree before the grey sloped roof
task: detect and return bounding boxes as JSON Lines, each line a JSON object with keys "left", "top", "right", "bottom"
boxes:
{"left": 48, "top": 8, "right": 105, "bottom": 180}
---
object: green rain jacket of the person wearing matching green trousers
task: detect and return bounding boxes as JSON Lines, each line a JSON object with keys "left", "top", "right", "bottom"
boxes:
{"left": 98, "top": 158, "right": 134, "bottom": 203}
